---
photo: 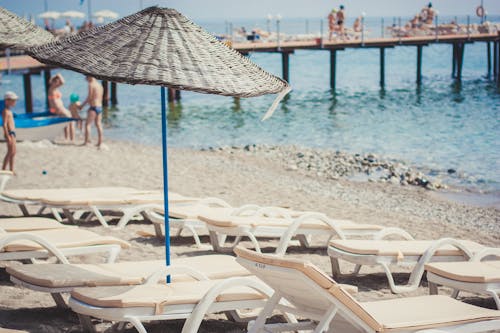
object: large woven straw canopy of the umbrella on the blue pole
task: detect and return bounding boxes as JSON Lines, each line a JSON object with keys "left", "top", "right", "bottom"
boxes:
{"left": 28, "top": 7, "right": 289, "bottom": 97}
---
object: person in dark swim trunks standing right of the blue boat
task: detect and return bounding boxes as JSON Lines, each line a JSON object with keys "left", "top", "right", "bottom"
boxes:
{"left": 81, "top": 75, "right": 104, "bottom": 148}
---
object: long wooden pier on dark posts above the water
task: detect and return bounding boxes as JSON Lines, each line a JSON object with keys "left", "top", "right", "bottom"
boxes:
{"left": 0, "top": 32, "right": 500, "bottom": 112}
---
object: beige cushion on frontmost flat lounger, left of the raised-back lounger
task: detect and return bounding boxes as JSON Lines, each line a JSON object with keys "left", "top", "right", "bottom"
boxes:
{"left": 71, "top": 280, "right": 265, "bottom": 314}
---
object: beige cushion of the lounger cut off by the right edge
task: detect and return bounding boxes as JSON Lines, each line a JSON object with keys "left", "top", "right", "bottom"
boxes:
{"left": 425, "top": 260, "right": 500, "bottom": 283}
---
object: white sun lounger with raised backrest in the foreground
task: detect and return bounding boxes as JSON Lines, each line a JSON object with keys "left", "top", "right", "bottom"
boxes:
{"left": 235, "top": 247, "right": 500, "bottom": 333}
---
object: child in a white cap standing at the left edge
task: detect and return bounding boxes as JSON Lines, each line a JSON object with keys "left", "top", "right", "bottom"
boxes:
{"left": 2, "top": 91, "right": 18, "bottom": 172}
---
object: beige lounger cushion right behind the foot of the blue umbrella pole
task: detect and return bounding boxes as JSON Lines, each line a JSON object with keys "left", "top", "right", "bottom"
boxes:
{"left": 7, "top": 254, "right": 250, "bottom": 288}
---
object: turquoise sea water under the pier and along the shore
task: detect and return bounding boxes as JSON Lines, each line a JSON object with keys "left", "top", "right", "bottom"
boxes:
{"left": 0, "top": 19, "right": 500, "bottom": 192}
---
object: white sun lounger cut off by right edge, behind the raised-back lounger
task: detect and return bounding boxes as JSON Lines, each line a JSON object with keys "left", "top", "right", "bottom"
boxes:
{"left": 425, "top": 248, "right": 500, "bottom": 310}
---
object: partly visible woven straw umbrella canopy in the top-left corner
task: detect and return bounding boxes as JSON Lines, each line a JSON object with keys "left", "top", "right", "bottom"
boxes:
{"left": 0, "top": 7, "right": 54, "bottom": 48}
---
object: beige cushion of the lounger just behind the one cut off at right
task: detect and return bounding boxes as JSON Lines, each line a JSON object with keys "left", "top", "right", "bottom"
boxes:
{"left": 330, "top": 239, "right": 484, "bottom": 258}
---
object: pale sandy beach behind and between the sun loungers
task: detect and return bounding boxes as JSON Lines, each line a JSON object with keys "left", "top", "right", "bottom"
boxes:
{"left": 0, "top": 142, "right": 500, "bottom": 332}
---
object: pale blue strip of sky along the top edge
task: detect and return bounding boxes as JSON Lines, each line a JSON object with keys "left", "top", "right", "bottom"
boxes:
{"left": 0, "top": 0, "right": 500, "bottom": 20}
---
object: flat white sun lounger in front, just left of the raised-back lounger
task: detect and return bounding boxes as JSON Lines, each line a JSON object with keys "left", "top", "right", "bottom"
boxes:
{"left": 68, "top": 272, "right": 271, "bottom": 333}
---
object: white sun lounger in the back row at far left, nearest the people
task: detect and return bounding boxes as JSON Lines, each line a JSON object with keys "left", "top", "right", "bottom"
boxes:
{"left": 0, "top": 187, "right": 197, "bottom": 227}
